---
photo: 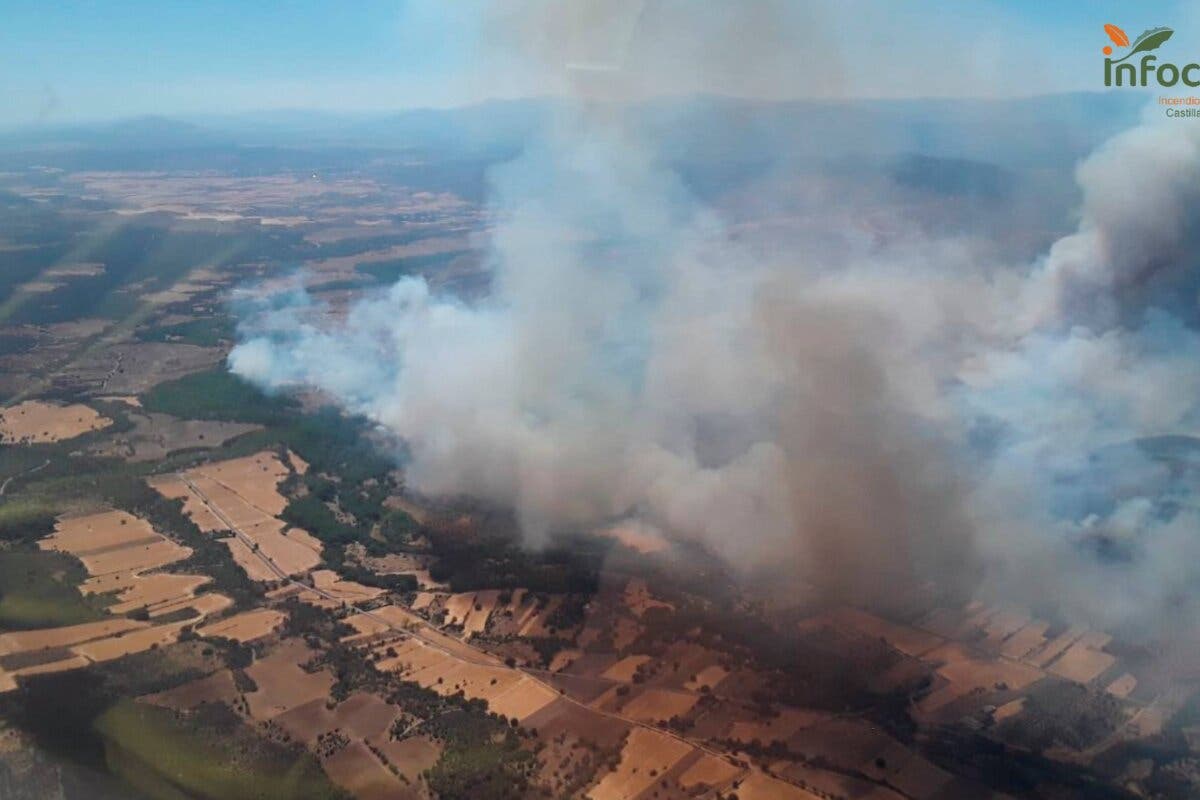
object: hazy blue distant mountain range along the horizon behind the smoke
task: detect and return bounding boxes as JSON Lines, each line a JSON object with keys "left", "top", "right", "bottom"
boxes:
{"left": 0, "top": 92, "right": 1147, "bottom": 168}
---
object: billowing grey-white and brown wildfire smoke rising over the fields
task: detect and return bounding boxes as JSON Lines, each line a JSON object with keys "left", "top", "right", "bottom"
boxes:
{"left": 229, "top": 2, "right": 1200, "bottom": 630}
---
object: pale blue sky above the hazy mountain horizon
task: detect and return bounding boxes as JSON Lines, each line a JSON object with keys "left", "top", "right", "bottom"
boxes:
{"left": 0, "top": 0, "right": 1200, "bottom": 126}
